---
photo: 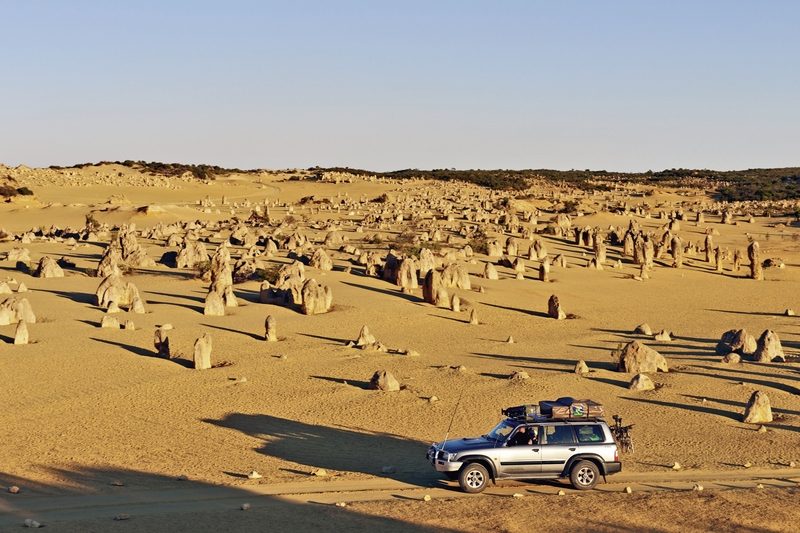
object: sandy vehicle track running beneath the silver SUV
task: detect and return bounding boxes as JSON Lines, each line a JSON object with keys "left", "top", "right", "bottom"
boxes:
{"left": 0, "top": 468, "right": 800, "bottom": 528}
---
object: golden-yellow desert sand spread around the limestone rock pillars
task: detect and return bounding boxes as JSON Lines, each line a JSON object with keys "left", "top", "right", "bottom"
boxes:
{"left": 0, "top": 165, "right": 800, "bottom": 531}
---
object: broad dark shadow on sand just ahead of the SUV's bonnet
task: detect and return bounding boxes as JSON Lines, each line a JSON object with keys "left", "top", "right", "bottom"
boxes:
{"left": 203, "top": 412, "right": 439, "bottom": 487}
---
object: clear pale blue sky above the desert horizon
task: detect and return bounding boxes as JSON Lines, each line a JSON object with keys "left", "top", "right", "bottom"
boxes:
{"left": 0, "top": 0, "right": 800, "bottom": 170}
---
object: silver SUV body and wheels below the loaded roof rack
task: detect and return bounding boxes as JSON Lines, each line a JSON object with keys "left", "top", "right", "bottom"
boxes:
{"left": 427, "top": 418, "right": 622, "bottom": 492}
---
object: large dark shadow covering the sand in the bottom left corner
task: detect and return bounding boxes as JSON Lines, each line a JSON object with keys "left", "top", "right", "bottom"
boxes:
{"left": 0, "top": 467, "right": 454, "bottom": 533}
